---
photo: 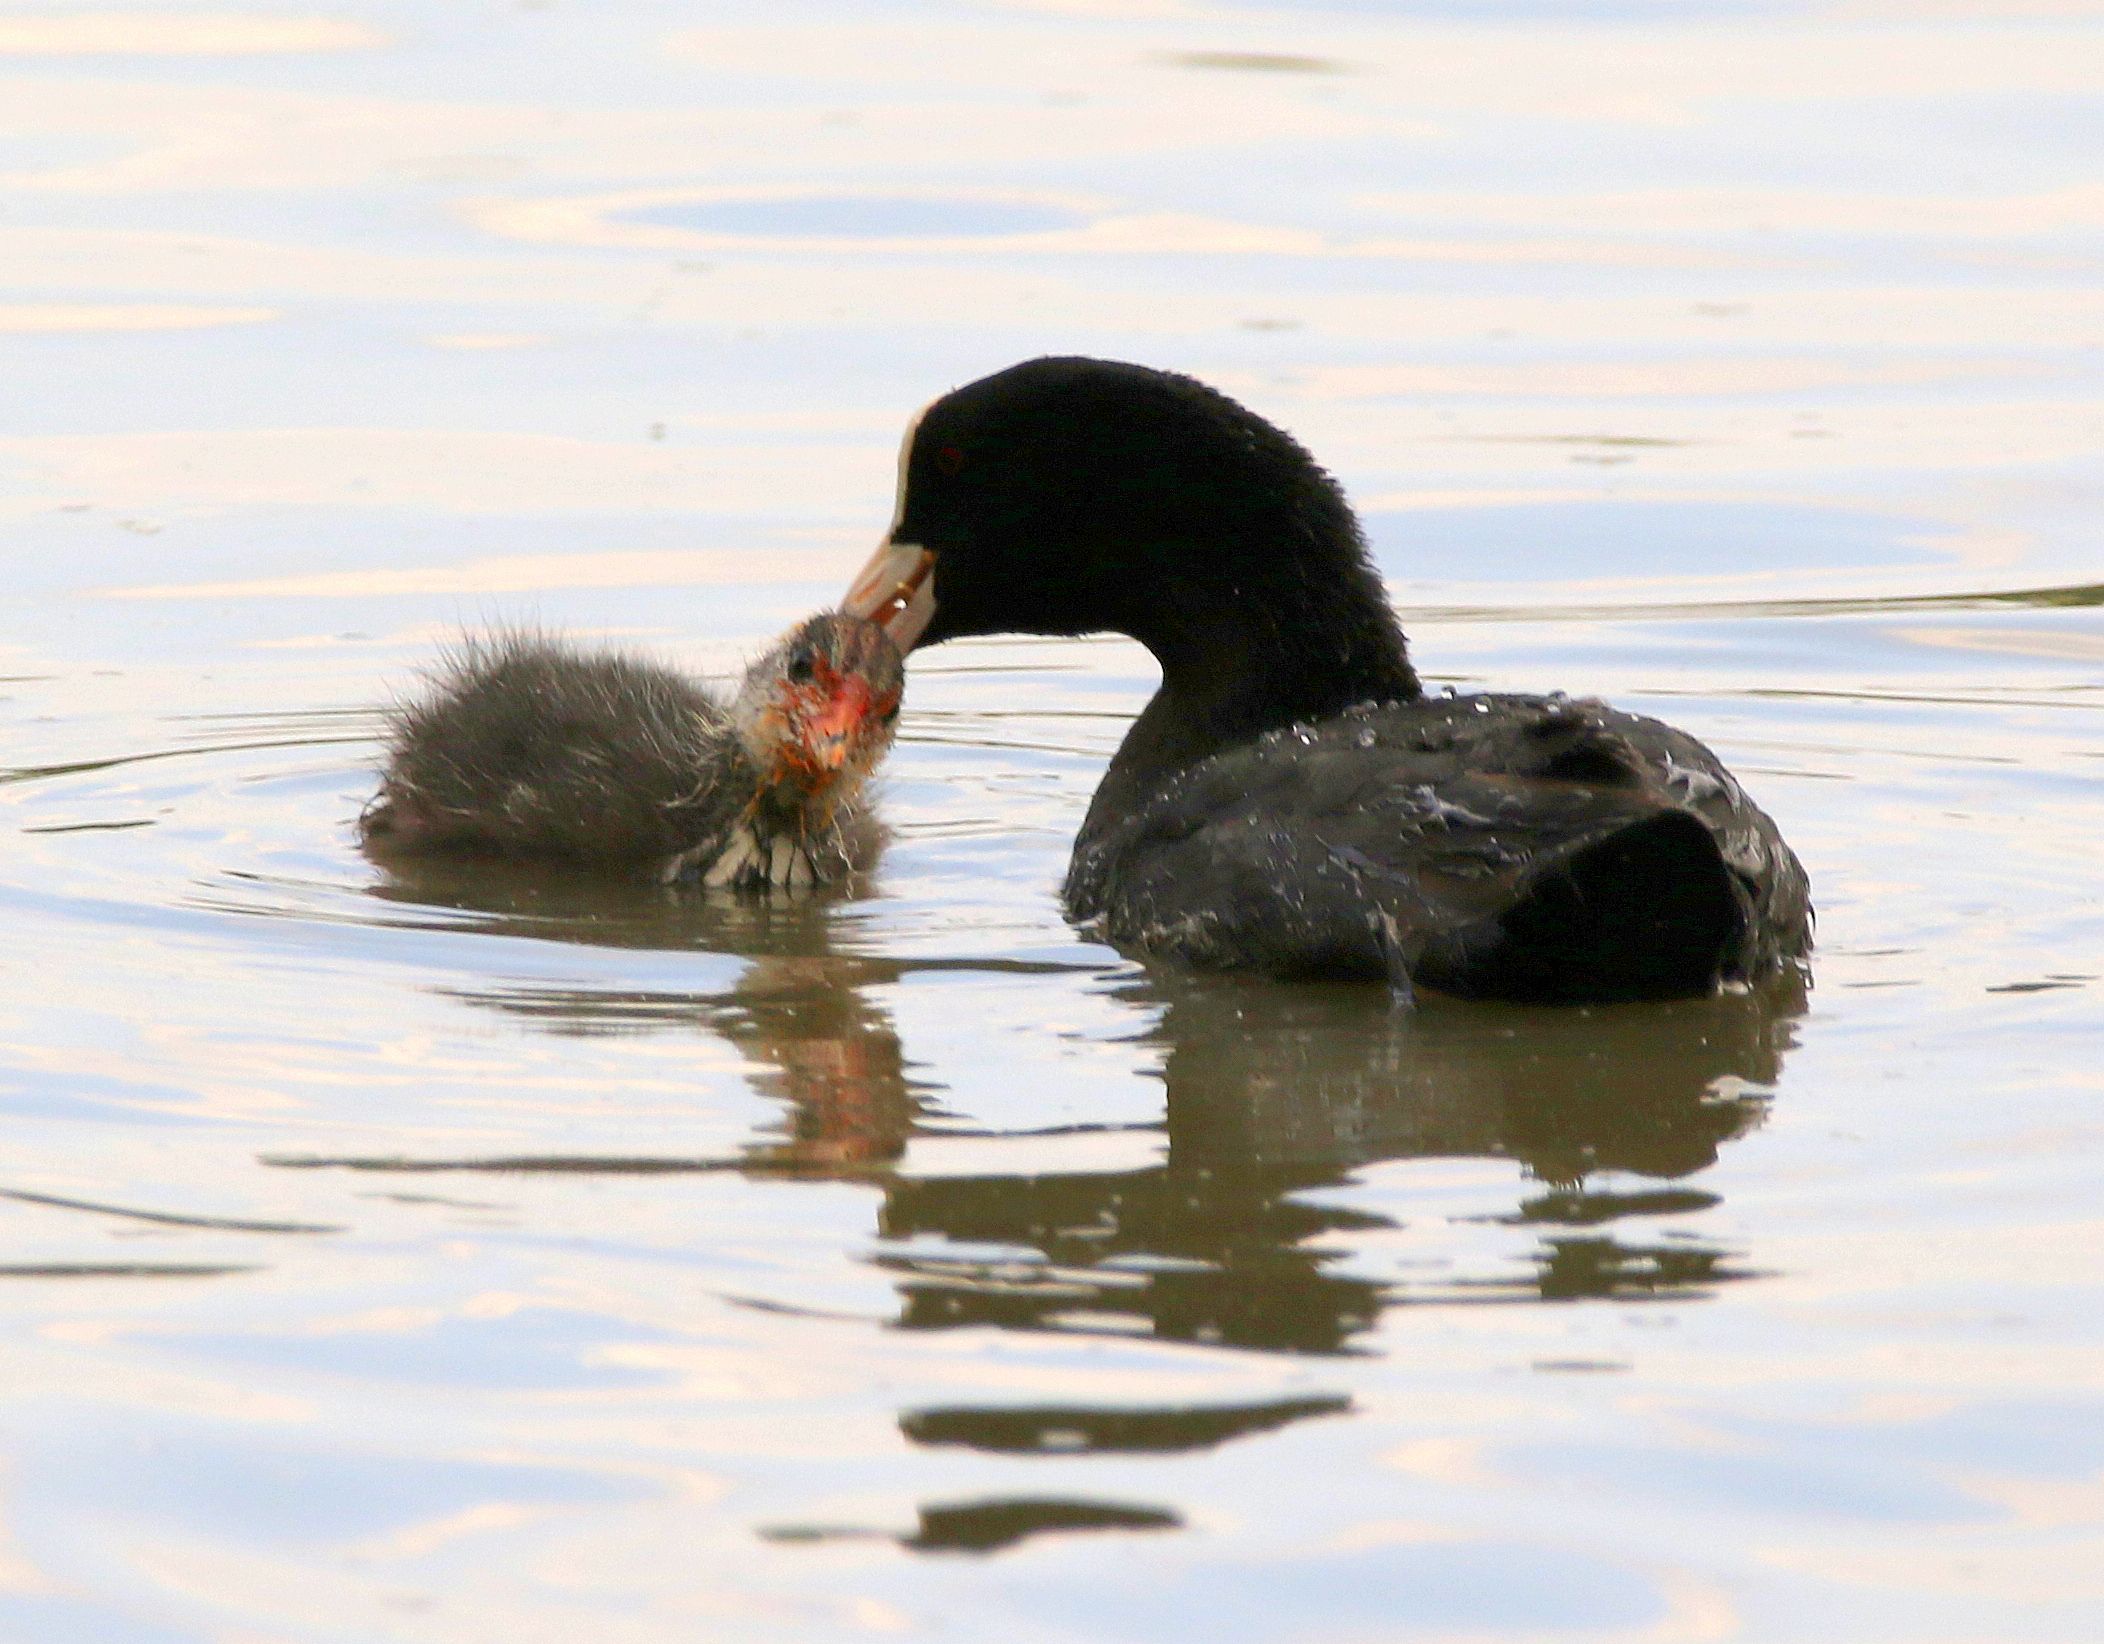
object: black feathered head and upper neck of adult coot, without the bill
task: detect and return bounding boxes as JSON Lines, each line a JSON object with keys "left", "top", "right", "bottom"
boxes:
{"left": 892, "top": 358, "right": 1416, "bottom": 699}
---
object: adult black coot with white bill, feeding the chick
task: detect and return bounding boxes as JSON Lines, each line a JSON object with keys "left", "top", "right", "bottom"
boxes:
{"left": 846, "top": 358, "right": 1812, "bottom": 1002}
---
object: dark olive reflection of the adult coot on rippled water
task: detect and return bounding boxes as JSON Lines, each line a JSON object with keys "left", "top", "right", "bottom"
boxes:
{"left": 879, "top": 977, "right": 1803, "bottom": 1354}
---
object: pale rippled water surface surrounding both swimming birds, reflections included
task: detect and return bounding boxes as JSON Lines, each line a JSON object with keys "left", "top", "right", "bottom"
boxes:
{"left": 0, "top": 0, "right": 2104, "bottom": 1644}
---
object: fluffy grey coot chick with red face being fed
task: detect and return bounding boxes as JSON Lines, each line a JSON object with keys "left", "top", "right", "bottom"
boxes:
{"left": 360, "top": 613, "right": 905, "bottom": 888}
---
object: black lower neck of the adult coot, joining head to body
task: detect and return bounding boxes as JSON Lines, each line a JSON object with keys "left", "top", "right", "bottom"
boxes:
{"left": 1090, "top": 541, "right": 1420, "bottom": 821}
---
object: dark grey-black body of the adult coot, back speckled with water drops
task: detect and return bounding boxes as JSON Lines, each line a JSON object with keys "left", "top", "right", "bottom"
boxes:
{"left": 1067, "top": 697, "right": 1807, "bottom": 1000}
